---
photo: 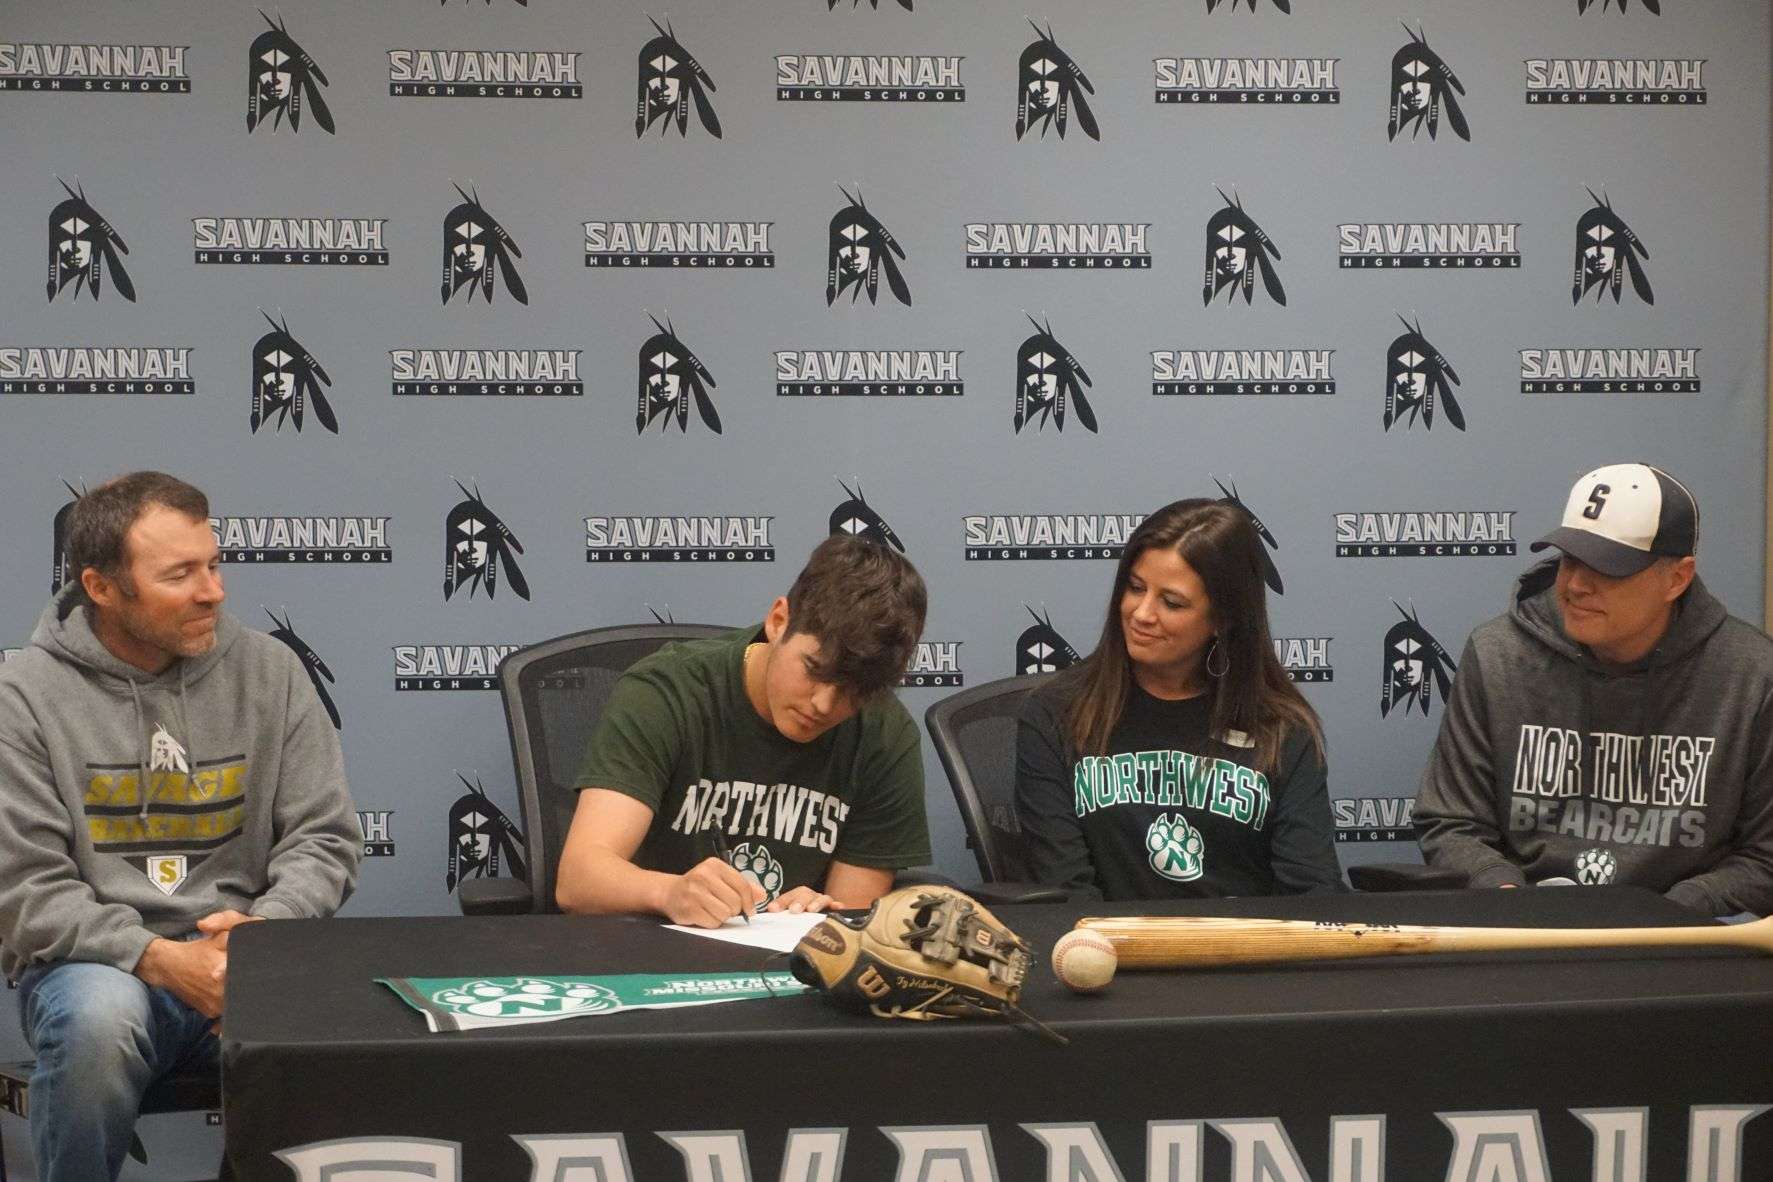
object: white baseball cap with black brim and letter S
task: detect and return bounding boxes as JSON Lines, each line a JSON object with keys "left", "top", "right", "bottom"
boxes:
{"left": 1532, "top": 464, "right": 1699, "bottom": 578}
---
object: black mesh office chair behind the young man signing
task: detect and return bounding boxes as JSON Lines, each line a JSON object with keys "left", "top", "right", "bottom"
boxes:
{"left": 456, "top": 624, "right": 732, "bottom": 914}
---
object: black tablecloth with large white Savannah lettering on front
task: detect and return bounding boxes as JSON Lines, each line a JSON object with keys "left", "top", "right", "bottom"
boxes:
{"left": 223, "top": 888, "right": 1773, "bottom": 1182}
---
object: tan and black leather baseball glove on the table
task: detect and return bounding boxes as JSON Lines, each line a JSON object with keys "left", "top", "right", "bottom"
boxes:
{"left": 789, "top": 886, "right": 1032, "bottom": 1021}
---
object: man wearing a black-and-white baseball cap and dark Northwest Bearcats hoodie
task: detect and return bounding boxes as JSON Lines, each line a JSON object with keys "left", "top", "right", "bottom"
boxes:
{"left": 1415, "top": 464, "right": 1773, "bottom": 914}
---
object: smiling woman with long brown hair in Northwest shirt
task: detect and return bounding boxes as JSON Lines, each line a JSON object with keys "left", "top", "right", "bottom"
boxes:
{"left": 1016, "top": 500, "right": 1342, "bottom": 898}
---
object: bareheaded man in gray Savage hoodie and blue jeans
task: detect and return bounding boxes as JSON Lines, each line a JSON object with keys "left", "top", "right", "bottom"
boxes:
{"left": 0, "top": 471, "right": 362, "bottom": 1182}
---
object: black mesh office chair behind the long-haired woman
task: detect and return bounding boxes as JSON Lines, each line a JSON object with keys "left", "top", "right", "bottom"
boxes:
{"left": 924, "top": 673, "right": 1066, "bottom": 902}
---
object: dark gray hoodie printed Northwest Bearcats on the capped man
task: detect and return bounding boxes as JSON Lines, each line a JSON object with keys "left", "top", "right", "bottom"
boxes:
{"left": 1415, "top": 560, "right": 1773, "bottom": 914}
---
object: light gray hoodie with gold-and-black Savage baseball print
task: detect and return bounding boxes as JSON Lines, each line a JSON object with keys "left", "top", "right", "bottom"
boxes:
{"left": 0, "top": 583, "right": 363, "bottom": 978}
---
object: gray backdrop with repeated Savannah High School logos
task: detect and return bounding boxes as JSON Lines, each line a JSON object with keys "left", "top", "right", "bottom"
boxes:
{"left": 0, "top": 0, "right": 1769, "bottom": 1176}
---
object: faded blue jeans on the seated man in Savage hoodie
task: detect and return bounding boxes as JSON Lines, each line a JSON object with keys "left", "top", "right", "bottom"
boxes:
{"left": 18, "top": 960, "right": 220, "bottom": 1182}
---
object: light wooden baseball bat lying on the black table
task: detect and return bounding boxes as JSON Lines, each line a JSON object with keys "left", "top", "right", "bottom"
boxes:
{"left": 1076, "top": 914, "right": 1773, "bottom": 969}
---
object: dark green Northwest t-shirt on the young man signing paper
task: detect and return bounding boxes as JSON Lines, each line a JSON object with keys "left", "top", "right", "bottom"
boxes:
{"left": 574, "top": 627, "right": 929, "bottom": 898}
